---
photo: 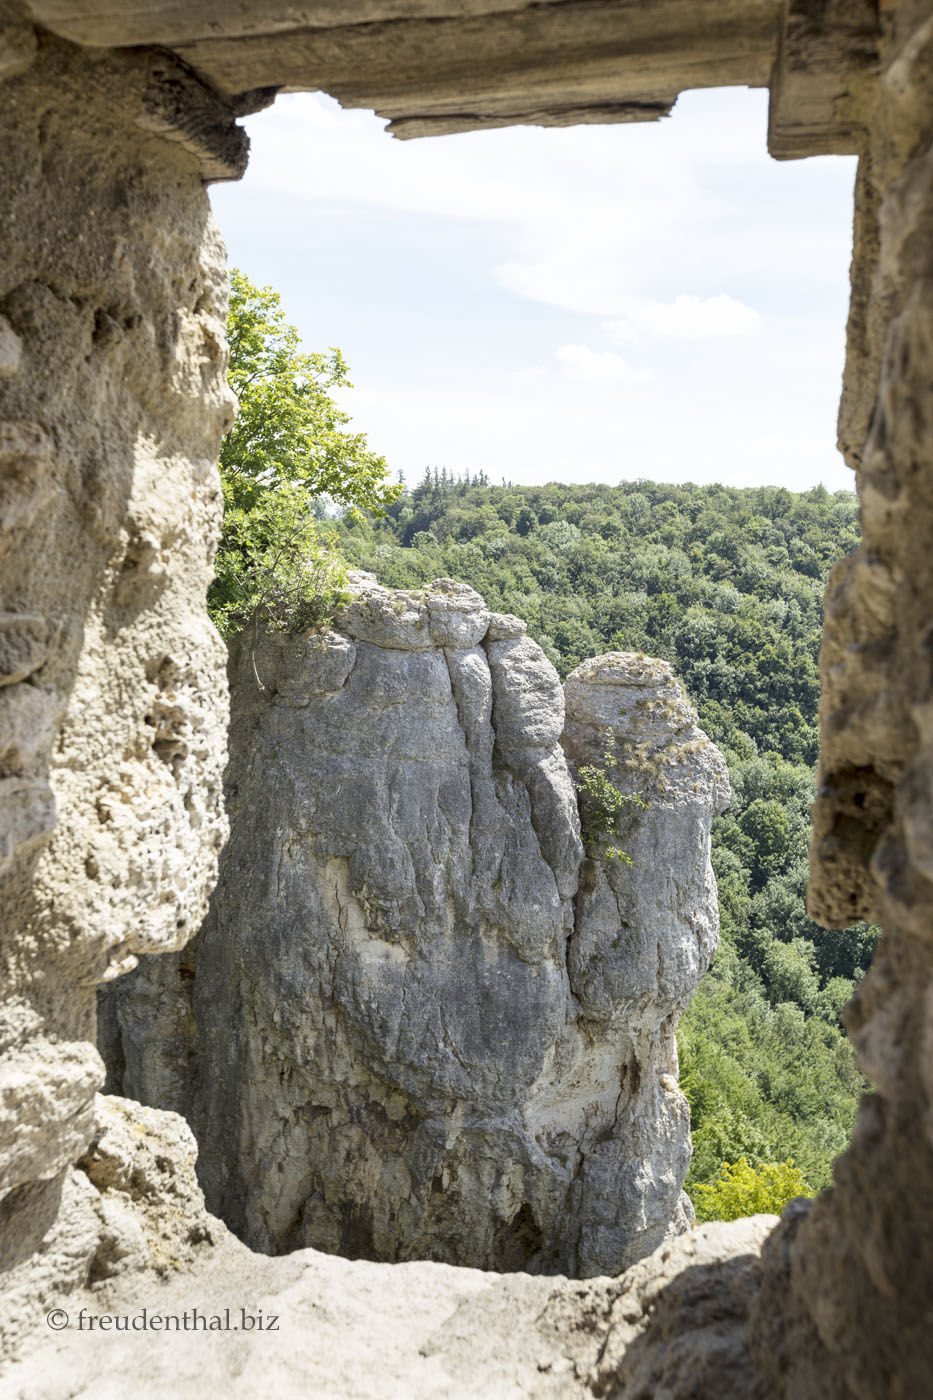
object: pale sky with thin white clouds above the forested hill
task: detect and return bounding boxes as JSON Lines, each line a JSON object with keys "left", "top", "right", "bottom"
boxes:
{"left": 212, "top": 88, "right": 855, "bottom": 490}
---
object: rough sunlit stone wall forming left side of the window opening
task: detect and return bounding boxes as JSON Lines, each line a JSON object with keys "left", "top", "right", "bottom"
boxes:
{"left": 0, "top": 30, "right": 233, "bottom": 1344}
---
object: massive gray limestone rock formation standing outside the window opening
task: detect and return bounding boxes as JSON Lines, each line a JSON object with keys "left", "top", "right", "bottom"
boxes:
{"left": 102, "top": 575, "right": 728, "bottom": 1275}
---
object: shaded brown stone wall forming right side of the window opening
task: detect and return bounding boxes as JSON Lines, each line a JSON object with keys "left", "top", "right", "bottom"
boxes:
{"left": 752, "top": 0, "right": 933, "bottom": 1400}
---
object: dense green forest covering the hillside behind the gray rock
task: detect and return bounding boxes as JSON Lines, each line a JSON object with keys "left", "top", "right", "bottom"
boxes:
{"left": 335, "top": 472, "right": 878, "bottom": 1196}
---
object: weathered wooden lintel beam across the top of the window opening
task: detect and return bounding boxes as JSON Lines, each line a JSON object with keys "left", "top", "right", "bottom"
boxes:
{"left": 23, "top": 0, "right": 780, "bottom": 137}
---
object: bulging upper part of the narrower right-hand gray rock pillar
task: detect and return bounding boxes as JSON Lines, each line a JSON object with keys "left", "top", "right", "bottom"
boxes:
{"left": 563, "top": 652, "right": 730, "bottom": 1036}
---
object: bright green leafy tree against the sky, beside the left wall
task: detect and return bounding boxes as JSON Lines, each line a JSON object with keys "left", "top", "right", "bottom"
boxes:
{"left": 207, "top": 267, "right": 402, "bottom": 634}
